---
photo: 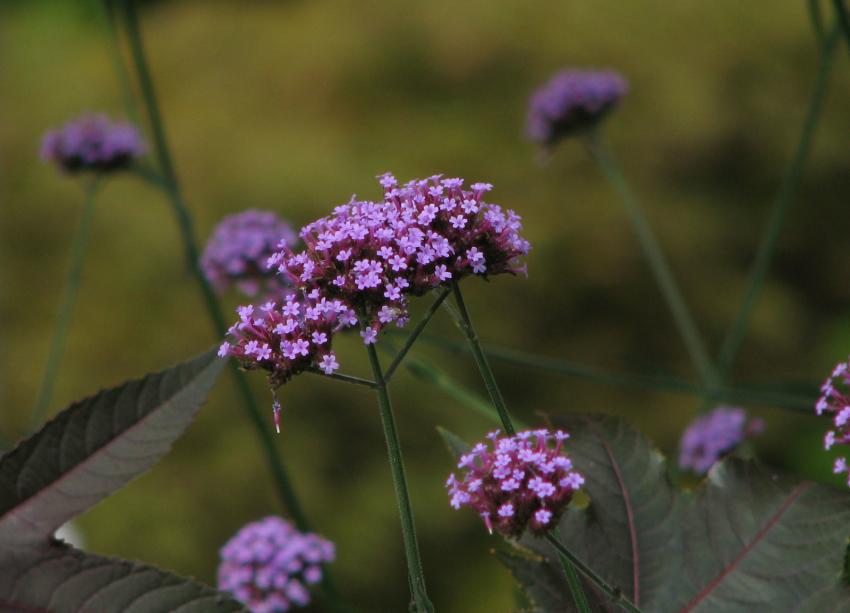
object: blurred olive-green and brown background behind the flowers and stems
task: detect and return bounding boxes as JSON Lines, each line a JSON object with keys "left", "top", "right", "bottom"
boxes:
{"left": 0, "top": 0, "right": 850, "bottom": 613}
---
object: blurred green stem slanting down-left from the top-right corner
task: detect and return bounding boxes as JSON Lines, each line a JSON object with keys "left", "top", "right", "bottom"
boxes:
{"left": 719, "top": 25, "right": 839, "bottom": 381}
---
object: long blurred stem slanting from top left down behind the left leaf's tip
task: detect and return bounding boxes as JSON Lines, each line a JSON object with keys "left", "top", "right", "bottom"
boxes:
{"left": 118, "top": 0, "right": 310, "bottom": 531}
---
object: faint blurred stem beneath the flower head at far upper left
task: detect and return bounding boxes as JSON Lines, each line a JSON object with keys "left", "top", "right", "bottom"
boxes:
{"left": 30, "top": 179, "right": 100, "bottom": 428}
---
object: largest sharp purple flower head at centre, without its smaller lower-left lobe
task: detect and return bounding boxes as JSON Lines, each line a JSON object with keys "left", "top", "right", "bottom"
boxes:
{"left": 270, "top": 173, "right": 530, "bottom": 343}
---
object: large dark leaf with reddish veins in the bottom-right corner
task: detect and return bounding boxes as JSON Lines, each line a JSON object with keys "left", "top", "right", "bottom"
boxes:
{"left": 494, "top": 415, "right": 850, "bottom": 613}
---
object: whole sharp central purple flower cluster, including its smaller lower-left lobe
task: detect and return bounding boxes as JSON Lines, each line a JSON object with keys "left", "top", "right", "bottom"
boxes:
{"left": 219, "top": 174, "right": 530, "bottom": 386}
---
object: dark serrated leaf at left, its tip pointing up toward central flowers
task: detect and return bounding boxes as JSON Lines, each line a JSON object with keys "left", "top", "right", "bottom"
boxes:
{"left": 0, "top": 352, "right": 224, "bottom": 551}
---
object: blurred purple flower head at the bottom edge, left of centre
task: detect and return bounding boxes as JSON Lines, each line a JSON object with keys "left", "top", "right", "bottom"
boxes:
{"left": 218, "top": 516, "right": 335, "bottom": 613}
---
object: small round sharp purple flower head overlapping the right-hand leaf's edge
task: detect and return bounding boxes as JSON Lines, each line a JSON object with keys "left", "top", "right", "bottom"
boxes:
{"left": 446, "top": 430, "right": 584, "bottom": 536}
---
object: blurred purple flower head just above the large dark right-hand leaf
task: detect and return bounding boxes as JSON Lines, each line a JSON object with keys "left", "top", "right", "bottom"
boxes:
{"left": 679, "top": 407, "right": 764, "bottom": 475}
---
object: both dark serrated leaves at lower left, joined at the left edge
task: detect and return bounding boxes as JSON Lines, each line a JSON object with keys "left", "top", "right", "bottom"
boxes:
{"left": 0, "top": 352, "right": 244, "bottom": 612}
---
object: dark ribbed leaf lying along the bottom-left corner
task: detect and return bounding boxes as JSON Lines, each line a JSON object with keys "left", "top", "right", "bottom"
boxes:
{"left": 0, "top": 542, "right": 247, "bottom": 613}
